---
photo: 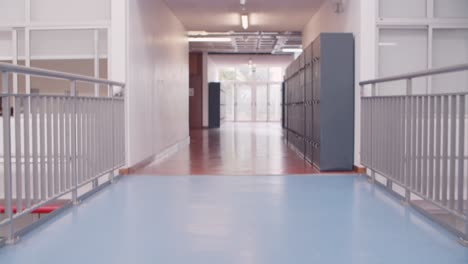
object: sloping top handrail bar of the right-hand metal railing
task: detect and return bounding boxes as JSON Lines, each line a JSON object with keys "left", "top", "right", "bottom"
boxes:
{"left": 359, "top": 64, "right": 468, "bottom": 86}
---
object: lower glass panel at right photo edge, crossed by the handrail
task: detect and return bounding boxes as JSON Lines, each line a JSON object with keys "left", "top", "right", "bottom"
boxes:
{"left": 432, "top": 29, "right": 468, "bottom": 93}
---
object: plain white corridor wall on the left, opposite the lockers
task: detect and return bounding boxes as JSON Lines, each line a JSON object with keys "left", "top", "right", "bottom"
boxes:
{"left": 126, "top": 0, "right": 189, "bottom": 166}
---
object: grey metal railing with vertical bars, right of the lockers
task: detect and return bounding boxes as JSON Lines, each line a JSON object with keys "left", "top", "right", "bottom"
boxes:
{"left": 360, "top": 64, "right": 468, "bottom": 242}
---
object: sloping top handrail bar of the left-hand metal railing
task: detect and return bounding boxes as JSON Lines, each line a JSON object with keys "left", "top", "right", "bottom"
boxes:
{"left": 0, "top": 63, "right": 125, "bottom": 88}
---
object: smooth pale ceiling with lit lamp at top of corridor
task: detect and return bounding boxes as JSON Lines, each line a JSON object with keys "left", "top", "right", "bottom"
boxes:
{"left": 165, "top": 0, "right": 325, "bottom": 32}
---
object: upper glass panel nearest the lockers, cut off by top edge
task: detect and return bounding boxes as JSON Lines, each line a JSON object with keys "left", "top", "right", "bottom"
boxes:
{"left": 379, "top": 0, "right": 426, "bottom": 18}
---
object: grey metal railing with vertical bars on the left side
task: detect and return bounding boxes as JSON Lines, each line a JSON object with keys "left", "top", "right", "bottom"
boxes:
{"left": 0, "top": 63, "right": 125, "bottom": 243}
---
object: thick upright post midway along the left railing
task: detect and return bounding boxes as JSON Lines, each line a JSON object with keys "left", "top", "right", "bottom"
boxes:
{"left": 70, "top": 80, "right": 79, "bottom": 204}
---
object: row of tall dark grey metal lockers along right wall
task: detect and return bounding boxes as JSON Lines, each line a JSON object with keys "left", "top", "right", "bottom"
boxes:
{"left": 285, "top": 33, "right": 354, "bottom": 171}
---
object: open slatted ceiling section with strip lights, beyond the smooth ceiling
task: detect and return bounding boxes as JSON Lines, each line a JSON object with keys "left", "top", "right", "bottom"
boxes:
{"left": 188, "top": 31, "right": 302, "bottom": 54}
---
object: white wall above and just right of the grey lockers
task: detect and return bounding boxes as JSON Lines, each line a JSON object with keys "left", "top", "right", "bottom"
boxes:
{"left": 302, "top": 0, "right": 364, "bottom": 164}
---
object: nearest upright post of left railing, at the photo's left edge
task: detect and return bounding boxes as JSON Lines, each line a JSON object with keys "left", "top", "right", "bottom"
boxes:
{"left": 2, "top": 71, "right": 16, "bottom": 244}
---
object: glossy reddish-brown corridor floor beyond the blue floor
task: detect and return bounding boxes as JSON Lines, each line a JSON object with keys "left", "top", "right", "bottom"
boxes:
{"left": 136, "top": 123, "right": 318, "bottom": 175}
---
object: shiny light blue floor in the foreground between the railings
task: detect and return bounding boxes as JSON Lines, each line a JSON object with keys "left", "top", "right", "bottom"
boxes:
{"left": 0, "top": 176, "right": 468, "bottom": 264}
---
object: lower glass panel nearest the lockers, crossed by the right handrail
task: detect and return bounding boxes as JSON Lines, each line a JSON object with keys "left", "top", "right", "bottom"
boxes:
{"left": 379, "top": 29, "right": 428, "bottom": 95}
